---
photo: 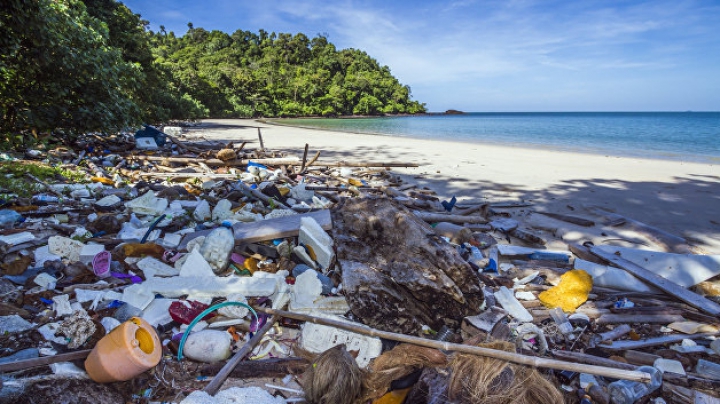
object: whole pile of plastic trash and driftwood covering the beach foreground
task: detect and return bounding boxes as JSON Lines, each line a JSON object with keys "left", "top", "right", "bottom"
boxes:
{"left": 0, "top": 126, "right": 720, "bottom": 404}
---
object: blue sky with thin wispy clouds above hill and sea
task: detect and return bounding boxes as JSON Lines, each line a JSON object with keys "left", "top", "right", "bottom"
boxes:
{"left": 123, "top": 0, "right": 720, "bottom": 111}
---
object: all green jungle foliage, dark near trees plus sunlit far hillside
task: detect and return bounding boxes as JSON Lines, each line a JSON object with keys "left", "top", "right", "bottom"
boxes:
{"left": 0, "top": 0, "right": 425, "bottom": 146}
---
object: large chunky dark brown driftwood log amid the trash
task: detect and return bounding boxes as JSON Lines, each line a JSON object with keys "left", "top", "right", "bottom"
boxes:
{"left": 332, "top": 198, "right": 483, "bottom": 334}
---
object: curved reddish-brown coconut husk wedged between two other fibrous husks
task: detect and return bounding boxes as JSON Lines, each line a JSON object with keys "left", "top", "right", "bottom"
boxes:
{"left": 361, "top": 344, "right": 447, "bottom": 402}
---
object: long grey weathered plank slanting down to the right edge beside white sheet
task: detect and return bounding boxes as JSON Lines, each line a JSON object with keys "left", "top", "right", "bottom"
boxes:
{"left": 590, "top": 247, "right": 720, "bottom": 316}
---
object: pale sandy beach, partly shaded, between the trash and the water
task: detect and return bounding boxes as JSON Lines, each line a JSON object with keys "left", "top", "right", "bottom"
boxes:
{"left": 184, "top": 119, "right": 720, "bottom": 254}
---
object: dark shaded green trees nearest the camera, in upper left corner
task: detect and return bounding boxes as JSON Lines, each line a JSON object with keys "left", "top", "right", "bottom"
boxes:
{"left": 0, "top": 0, "right": 139, "bottom": 139}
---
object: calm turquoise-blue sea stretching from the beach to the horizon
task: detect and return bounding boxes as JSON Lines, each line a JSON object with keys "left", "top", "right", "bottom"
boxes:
{"left": 279, "top": 112, "right": 720, "bottom": 164}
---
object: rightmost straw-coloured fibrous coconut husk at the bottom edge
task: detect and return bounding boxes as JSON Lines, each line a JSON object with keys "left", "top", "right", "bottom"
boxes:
{"left": 448, "top": 341, "right": 564, "bottom": 404}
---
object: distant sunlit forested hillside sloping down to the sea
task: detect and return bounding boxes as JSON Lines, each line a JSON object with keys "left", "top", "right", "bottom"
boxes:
{"left": 152, "top": 24, "right": 424, "bottom": 117}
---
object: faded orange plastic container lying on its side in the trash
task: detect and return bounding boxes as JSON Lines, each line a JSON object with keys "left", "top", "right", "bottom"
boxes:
{"left": 85, "top": 317, "right": 162, "bottom": 383}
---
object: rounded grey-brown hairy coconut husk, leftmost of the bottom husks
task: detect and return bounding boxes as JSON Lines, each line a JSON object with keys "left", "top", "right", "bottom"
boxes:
{"left": 302, "top": 345, "right": 364, "bottom": 404}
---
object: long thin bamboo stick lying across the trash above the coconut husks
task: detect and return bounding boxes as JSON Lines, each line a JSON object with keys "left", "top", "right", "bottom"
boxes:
{"left": 255, "top": 308, "right": 650, "bottom": 382}
